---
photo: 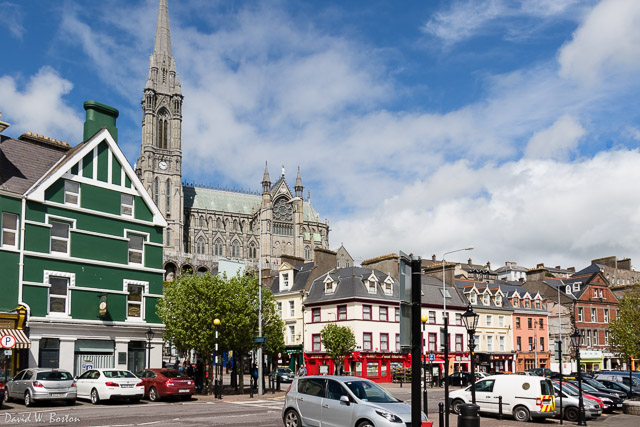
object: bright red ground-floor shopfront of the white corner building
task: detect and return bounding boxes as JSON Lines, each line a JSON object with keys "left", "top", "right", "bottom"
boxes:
{"left": 304, "top": 351, "right": 411, "bottom": 383}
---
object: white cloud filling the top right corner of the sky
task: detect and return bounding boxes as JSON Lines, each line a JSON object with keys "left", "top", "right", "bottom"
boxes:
{"left": 558, "top": 0, "right": 640, "bottom": 85}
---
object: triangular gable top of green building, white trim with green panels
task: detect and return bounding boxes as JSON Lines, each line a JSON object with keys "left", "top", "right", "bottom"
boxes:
{"left": 25, "top": 129, "right": 167, "bottom": 227}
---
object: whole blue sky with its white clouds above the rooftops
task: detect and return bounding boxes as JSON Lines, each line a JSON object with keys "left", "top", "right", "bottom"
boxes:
{"left": 0, "top": 0, "right": 640, "bottom": 268}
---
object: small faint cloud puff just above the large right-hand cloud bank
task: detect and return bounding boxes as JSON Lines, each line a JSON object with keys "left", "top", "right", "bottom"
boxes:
{"left": 525, "top": 115, "right": 585, "bottom": 160}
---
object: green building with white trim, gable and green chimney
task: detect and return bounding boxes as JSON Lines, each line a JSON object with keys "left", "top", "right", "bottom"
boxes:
{"left": 0, "top": 101, "right": 166, "bottom": 374}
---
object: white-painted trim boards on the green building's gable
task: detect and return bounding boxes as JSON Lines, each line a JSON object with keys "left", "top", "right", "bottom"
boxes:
{"left": 25, "top": 129, "right": 167, "bottom": 227}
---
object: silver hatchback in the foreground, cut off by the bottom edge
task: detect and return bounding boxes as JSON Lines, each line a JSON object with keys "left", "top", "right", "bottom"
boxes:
{"left": 282, "top": 375, "right": 427, "bottom": 427}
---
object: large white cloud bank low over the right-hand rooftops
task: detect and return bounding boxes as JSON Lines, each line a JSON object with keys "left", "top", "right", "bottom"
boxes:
{"left": 330, "top": 150, "right": 640, "bottom": 268}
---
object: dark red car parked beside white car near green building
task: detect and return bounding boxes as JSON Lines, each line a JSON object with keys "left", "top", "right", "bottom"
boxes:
{"left": 137, "top": 369, "right": 196, "bottom": 402}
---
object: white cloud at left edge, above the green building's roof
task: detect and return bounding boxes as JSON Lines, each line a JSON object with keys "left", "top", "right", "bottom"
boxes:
{"left": 0, "top": 67, "right": 83, "bottom": 145}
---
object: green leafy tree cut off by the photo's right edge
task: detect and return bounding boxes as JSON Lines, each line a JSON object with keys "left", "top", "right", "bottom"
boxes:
{"left": 609, "top": 285, "right": 640, "bottom": 359}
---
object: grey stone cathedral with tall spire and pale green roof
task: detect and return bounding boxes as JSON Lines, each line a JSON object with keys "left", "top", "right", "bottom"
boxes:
{"left": 135, "top": 0, "right": 329, "bottom": 280}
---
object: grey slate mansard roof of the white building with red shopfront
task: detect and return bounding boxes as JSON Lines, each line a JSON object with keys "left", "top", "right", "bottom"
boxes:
{"left": 305, "top": 267, "right": 400, "bottom": 304}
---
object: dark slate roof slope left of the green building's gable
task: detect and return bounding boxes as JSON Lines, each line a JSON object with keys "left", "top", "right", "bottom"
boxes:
{"left": 0, "top": 136, "right": 69, "bottom": 195}
